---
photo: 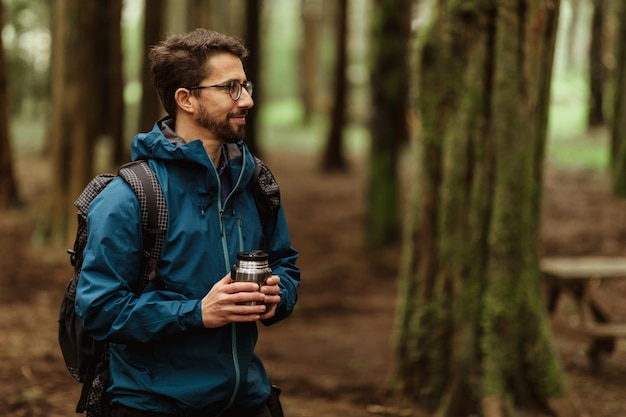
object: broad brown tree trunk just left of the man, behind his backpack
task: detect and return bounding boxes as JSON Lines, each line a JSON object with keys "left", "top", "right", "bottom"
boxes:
{"left": 44, "top": 0, "right": 100, "bottom": 242}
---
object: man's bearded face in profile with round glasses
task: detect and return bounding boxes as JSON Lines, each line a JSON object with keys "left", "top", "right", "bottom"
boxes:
{"left": 194, "top": 53, "right": 254, "bottom": 142}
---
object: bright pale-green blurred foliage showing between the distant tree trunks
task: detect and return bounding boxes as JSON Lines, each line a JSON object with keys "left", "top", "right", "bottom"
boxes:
{"left": 2, "top": 0, "right": 608, "bottom": 169}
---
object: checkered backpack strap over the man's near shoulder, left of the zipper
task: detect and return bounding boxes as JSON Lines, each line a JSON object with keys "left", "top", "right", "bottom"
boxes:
{"left": 119, "top": 160, "right": 168, "bottom": 292}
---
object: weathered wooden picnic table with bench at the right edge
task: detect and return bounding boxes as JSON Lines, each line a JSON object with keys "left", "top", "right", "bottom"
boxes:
{"left": 541, "top": 257, "right": 626, "bottom": 371}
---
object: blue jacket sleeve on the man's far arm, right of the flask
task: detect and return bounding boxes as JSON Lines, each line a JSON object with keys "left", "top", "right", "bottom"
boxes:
{"left": 262, "top": 204, "right": 300, "bottom": 326}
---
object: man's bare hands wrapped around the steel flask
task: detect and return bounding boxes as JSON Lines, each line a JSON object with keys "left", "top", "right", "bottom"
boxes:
{"left": 202, "top": 273, "right": 266, "bottom": 328}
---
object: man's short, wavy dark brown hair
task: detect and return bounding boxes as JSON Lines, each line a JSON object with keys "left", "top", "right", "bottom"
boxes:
{"left": 148, "top": 29, "right": 248, "bottom": 119}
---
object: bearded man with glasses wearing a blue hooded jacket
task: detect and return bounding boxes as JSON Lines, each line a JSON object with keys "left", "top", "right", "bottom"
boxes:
{"left": 76, "top": 29, "right": 300, "bottom": 417}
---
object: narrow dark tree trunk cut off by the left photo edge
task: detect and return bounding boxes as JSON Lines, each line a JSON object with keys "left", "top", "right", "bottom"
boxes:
{"left": 0, "top": 3, "right": 20, "bottom": 209}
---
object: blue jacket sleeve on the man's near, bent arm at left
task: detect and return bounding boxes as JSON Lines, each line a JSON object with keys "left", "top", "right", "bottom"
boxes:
{"left": 76, "top": 178, "right": 202, "bottom": 344}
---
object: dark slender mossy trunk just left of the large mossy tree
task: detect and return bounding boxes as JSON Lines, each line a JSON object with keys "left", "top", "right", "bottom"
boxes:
{"left": 366, "top": 0, "right": 412, "bottom": 246}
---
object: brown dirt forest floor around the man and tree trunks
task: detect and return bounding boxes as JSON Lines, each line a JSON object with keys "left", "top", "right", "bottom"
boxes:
{"left": 0, "top": 155, "right": 626, "bottom": 417}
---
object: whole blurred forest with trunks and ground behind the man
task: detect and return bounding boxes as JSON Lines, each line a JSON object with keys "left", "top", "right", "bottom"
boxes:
{"left": 0, "top": 0, "right": 626, "bottom": 417}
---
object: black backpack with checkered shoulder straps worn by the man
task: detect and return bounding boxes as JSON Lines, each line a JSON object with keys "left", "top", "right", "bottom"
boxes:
{"left": 58, "top": 156, "right": 280, "bottom": 417}
